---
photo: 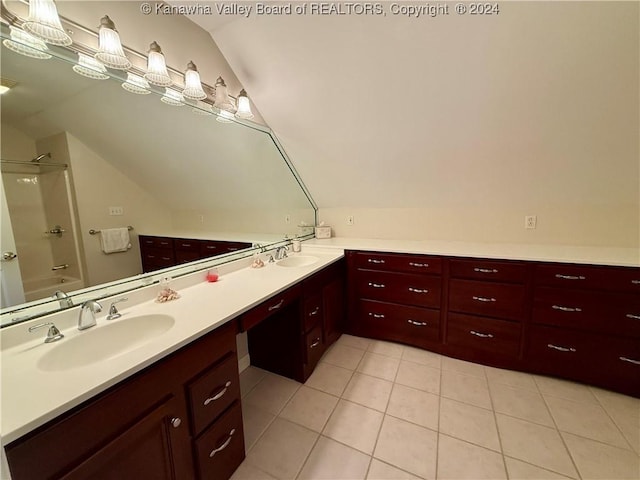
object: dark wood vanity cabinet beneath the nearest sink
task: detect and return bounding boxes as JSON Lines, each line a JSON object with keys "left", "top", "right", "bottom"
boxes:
{"left": 6, "top": 322, "right": 244, "bottom": 480}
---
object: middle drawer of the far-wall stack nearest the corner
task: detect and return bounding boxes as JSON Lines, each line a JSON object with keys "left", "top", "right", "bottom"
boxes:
{"left": 357, "top": 270, "right": 441, "bottom": 308}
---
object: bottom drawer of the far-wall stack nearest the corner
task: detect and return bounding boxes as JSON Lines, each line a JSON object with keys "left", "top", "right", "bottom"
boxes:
{"left": 357, "top": 300, "right": 440, "bottom": 345}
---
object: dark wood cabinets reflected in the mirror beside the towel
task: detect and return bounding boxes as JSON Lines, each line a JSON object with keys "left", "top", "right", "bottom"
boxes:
{"left": 139, "top": 235, "right": 251, "bottom": 273}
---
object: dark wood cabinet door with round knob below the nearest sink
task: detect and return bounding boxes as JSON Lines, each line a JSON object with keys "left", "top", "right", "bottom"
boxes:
{"left": 62, "top": 397, "right": 193, "bottom": 480}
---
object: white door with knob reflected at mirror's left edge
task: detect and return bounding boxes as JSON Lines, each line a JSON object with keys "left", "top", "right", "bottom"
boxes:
{"left": 0, "top": 181, "right": 25, "bottom": 308}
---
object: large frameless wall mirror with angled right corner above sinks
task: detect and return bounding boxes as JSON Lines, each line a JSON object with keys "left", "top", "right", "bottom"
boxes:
{"left": 0, "top": 10, "right": 316, "bottom": 326}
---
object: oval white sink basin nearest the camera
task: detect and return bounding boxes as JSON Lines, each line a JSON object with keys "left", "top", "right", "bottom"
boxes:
{"left": 38, "top": 314, "right": 175, "bottom": 372}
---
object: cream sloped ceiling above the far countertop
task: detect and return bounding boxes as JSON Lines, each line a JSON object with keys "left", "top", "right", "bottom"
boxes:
{"left": 182, "top": 2, "right": 638, "bottom": 208}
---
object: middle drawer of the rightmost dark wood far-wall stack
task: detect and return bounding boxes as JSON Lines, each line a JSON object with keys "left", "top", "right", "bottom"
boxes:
{"left": 532, "top": 287, "right": 640, "bottom": 337}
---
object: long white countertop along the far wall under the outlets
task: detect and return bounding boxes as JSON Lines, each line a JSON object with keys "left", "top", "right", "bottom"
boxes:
{"left": 305, "top": 237, "right": 640, "bottom": 267}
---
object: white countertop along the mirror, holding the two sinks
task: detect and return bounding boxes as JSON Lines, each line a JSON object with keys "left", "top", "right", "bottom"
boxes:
{"left": 0, "top": 246, "right": 343, "bottom": 445}
